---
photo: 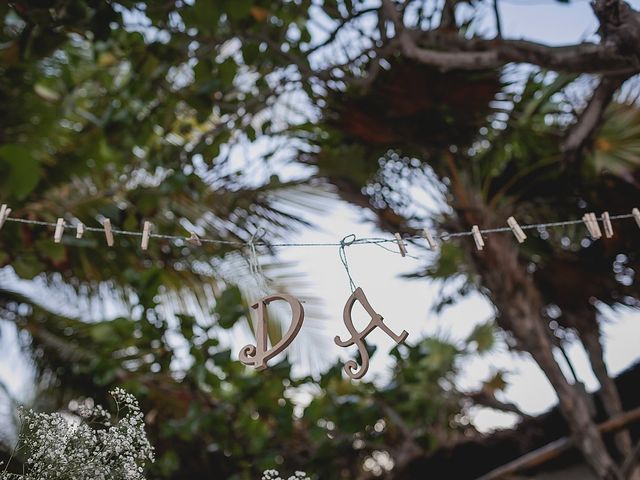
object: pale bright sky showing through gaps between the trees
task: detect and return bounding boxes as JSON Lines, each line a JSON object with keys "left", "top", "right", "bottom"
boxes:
{"left": 0, "top": 0, "right": 640, "bottom": 431}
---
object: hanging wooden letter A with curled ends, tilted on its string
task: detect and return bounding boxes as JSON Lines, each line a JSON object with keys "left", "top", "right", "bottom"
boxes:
{"left": 334, "top": 287, "right": 409, "bottom": 380}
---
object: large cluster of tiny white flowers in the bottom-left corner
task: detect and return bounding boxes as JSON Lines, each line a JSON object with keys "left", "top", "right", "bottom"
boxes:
{"left": 0, "top": 388, "right": 154, "bottom": 480}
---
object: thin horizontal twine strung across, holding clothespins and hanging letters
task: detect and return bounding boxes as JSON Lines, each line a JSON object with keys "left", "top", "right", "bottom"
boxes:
{"left": 5, "top": 213, "right": 634, "bottom": 248}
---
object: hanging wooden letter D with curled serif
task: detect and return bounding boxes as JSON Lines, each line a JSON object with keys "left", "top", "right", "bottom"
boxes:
{"left": 239, "top": 293, "right": 304, "bottom": 370}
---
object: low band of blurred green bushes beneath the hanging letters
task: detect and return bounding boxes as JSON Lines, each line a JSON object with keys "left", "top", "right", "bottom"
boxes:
{"left": 5, "top": 282, "right": 488, "bottom": 479}
